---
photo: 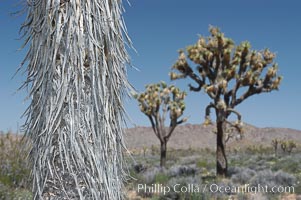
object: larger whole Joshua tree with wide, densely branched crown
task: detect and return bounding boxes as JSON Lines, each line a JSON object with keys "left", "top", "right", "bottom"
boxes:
{"left": 170, "top": 27, "right": 282, "bottom": 175}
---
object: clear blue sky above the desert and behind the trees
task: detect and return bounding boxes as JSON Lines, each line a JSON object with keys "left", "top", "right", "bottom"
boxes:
{"left": 0, "top": 0, "right": 301, "bottom": 131}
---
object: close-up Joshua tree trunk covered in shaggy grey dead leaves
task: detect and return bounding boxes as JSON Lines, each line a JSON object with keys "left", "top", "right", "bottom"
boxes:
{"left": 21, "top": 0, "right": 130, "bottom": 199}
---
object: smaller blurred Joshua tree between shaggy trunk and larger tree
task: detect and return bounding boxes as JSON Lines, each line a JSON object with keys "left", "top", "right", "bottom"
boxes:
{"left": 134, "top": 82, "right": 187, "bottom": 167}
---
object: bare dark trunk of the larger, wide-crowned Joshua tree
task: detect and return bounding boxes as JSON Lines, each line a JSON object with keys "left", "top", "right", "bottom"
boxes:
{"left": 216, "top": 119, "right": 228, "bottom": 176}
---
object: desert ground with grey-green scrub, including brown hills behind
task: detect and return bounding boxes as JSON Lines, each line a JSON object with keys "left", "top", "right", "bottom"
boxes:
{"left": 0, "top": 124, "right": 301, "bottom": 200}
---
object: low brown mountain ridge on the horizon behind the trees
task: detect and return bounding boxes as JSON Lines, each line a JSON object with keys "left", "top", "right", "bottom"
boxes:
{"left": 125, "top": 124, "right": 301, "bottom": 149}
